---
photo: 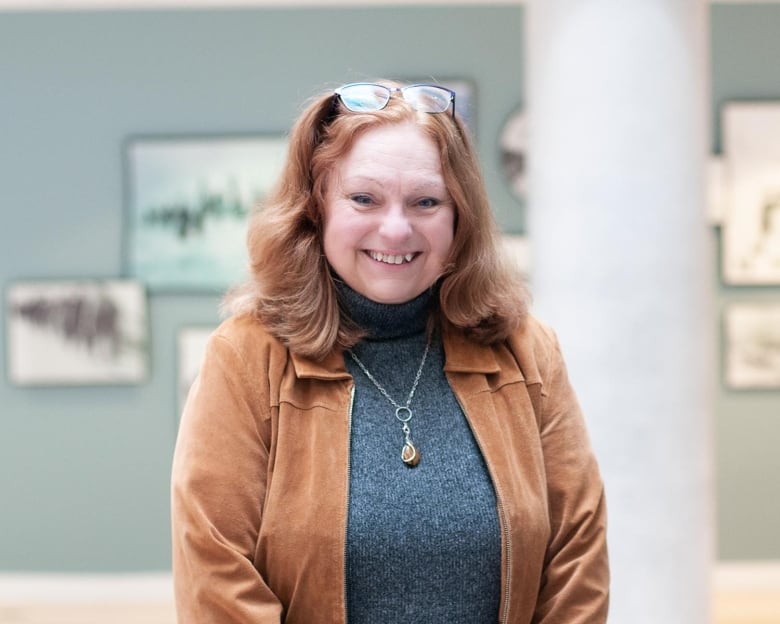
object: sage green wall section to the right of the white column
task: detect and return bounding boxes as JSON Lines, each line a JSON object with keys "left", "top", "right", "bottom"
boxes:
{"left": 711, "top": 3, "right": 780, "bottom": 559}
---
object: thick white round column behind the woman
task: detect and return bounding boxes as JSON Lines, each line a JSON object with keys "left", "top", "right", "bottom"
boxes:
{"left": 526, "top": 0, "right": 716, "bottom": 624}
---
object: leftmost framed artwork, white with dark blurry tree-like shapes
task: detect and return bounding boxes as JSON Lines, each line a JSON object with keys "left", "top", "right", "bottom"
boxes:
{"left": 7, "top": 280, "right": 149, "bottom": 385}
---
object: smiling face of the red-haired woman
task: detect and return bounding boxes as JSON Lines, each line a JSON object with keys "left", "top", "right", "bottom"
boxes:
{"left": 323, "top": 123, "right": 455, "bottom": 303}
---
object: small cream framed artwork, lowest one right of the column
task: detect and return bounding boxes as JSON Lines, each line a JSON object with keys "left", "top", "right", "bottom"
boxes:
{"left": 725, "top": 303, "right": 780, "bottom": 388}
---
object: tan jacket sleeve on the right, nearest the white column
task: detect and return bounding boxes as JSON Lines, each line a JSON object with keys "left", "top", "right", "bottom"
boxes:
{"left": 534, "top": 329, "right": 609, "bottom": 624}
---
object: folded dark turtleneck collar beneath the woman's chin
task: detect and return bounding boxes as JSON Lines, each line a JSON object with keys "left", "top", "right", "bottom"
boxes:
{"left": 333, "top": 275, "right": 438, "bottom": 340}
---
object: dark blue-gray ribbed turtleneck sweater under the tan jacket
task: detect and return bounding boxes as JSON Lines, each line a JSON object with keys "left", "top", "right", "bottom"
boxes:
{"left": 339, "top": 283, "right": 501, "bottom": 624}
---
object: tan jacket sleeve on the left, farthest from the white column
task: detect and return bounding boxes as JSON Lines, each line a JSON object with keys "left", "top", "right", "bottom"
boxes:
{"left": 171, "top": 334, "right": 282, "bottom": 624}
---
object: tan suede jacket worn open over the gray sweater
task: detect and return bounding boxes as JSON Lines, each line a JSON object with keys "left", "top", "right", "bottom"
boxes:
{"left": 172, "top": 317, "right": 609, "bottom": 624}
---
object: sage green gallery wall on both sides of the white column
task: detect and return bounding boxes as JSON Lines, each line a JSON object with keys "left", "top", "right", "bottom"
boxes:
{"left": 0, "top": 4, "right": 780, "bottom": 572}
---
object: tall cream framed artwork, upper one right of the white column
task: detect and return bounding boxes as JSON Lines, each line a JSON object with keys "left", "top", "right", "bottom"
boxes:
{"left": 723, "top": 102, "right": 780, "bottom": 284}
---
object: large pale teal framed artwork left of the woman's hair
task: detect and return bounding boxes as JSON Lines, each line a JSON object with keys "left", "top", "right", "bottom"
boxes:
{"left": 125, "top": 136, "right": 287, "bottom": 293}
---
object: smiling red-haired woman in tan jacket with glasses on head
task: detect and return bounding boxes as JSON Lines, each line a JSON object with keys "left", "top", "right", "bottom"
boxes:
{"left": 173, "top": 83, "right": 608, "bottom": 624}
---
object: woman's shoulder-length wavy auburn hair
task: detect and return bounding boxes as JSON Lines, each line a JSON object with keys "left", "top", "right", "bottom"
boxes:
{"left": 222, "top": 82, "right": 528, "bottom": 359}
